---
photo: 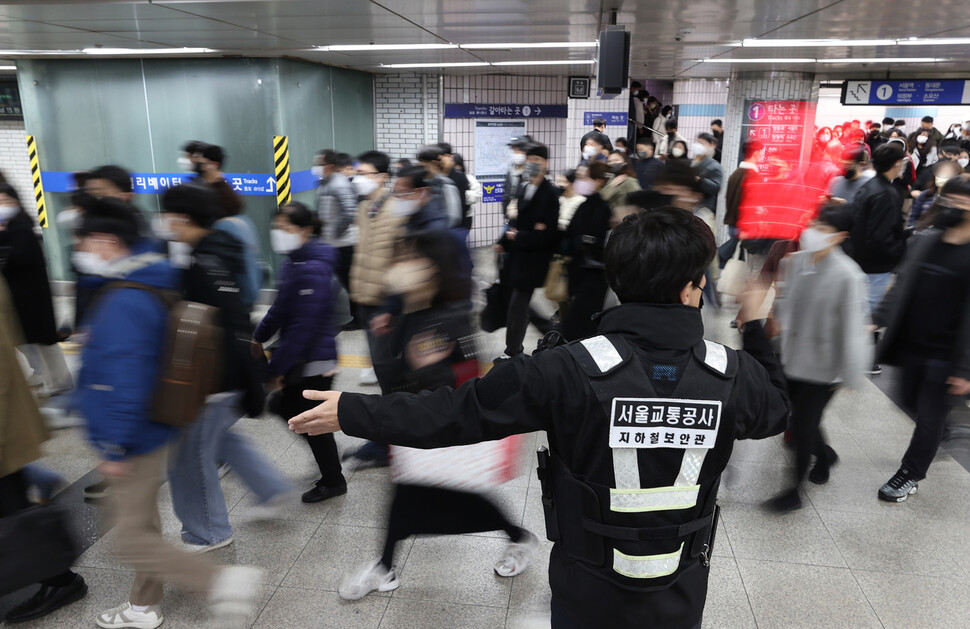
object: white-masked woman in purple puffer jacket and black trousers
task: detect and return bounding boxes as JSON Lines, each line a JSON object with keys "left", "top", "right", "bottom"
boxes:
{"left": 253, "top": 202, "right": 347, "bottom": 503}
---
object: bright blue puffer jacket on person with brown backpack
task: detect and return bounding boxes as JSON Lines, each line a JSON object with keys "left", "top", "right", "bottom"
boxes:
{"left": 76, "top": 253, "right": 178, "bottom": 461}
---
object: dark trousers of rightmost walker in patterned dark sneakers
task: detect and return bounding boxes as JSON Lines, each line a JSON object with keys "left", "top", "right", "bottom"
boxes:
{"left": 899, "top": 354, "right": 959, "bottom": 480}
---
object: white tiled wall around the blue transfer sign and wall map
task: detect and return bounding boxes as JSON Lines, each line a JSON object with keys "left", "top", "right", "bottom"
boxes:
{"left": 443, "top": 74, "right": 572, "bottom": 247}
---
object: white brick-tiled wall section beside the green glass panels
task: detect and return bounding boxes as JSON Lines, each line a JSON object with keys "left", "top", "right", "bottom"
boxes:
{"left": 374, "top": 72, "right": 439, "bottom": 160}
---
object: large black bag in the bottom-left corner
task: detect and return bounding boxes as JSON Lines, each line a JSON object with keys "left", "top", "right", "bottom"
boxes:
{"left": 0, "top": 504, "right": 81, "bottom": 596}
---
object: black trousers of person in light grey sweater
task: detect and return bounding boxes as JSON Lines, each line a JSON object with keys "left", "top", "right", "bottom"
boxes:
{"left": 788, "top": 380, "right": 835, "bottom": 487}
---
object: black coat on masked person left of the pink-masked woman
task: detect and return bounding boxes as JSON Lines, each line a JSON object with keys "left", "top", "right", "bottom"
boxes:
{"left": 498, "top": 179, "right": 559, "bottom": 291}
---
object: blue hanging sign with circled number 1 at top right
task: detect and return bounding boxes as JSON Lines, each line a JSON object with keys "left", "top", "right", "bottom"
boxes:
{"left": 842, "top": 79, "right": 970, "bottom": 105}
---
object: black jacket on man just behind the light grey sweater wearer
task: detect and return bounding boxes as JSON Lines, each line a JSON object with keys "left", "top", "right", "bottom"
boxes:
{"left": 846, "top": 175, "right": 906, "bottom": 273}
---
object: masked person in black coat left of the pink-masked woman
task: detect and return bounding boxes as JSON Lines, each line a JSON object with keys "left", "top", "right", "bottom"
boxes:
{"left": 496, "top": 142, "right": 559, "bottom": 357}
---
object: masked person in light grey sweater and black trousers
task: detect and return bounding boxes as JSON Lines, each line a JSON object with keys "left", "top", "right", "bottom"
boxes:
{"left": 767, "top": 203, "right": 872, "bottom": 513}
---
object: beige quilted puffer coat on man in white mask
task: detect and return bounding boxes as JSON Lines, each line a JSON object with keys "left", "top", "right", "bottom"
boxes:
{"left": 350, "top": 196, "right": 410, "bottom": 307}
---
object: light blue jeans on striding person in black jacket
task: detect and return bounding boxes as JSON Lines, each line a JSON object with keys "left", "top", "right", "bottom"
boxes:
{"left": 168, "top": 391, "right": 293, "bottom": 546}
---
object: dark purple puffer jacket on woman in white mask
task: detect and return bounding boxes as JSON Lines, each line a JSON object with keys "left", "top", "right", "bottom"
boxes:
{"left": 253, "top": 240, "right": 337, "bottom": 376}
